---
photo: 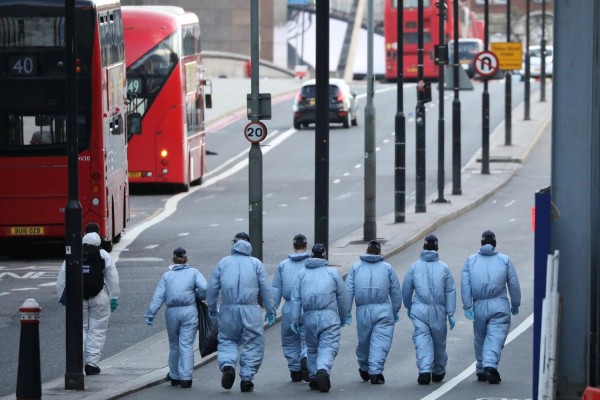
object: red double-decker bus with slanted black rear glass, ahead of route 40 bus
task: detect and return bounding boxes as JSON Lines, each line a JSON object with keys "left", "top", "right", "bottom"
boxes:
{"left": 123, "top": 6, "right": 210, "bottom": 191}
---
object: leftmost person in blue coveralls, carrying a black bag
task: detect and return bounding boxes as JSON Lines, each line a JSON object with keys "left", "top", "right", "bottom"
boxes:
{"left": 144, "top": 247, "right": 207, "bottom": 388}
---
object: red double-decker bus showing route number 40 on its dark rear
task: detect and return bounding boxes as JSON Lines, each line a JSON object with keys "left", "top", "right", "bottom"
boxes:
{"left": 0, "top": 0, "right": 129, "bottom": 249}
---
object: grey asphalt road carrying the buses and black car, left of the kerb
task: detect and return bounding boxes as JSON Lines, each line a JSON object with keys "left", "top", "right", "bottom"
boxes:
{"left": 0, "top": 76, "right": 536, "bottom": 396}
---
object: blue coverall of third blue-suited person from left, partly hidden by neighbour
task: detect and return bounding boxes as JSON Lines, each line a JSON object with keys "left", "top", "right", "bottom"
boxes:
{"left": 273, "top": 251, "right": 310, "bottom": 371}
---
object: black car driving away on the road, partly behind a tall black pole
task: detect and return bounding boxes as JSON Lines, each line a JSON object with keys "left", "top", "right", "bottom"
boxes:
{"left": 293, "top": 79, "right": 358, "bottom": 129}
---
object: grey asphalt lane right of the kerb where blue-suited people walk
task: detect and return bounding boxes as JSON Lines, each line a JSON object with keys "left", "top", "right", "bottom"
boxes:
{"left": 120, "top": 86, "right": 550, "bottom": 400}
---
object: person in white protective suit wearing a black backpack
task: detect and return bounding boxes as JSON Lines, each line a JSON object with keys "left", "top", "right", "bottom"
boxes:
{"left": 56, "top": 232, "right": 120, "bottom": 375}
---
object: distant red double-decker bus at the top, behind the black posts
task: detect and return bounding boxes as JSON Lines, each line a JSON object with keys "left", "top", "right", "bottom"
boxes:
{"left": 390, "top": 0, "right": 482, "bottom": 81}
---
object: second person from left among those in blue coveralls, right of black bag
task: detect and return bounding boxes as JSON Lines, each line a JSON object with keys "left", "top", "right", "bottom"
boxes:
{"left": 207, "top": 232, "right": 275, "bottom": 392}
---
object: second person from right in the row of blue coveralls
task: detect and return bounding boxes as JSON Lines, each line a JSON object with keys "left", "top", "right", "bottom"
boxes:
{"left": 402, "top": 235, "right": 456, "bottom": 385}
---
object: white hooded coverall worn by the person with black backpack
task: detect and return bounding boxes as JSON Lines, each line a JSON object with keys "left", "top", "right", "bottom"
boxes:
{"left": 56, "top": 249, "right": 121, "bottom": 367}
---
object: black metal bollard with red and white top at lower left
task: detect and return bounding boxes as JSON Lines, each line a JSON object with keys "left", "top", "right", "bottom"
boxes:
{"left": 16, "top": 299, "right": 42, "bottom": 400}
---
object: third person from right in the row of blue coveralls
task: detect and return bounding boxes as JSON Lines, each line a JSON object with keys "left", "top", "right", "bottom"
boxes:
{"left": 346, "top": 240, "right": 402, "bottom": 384}
